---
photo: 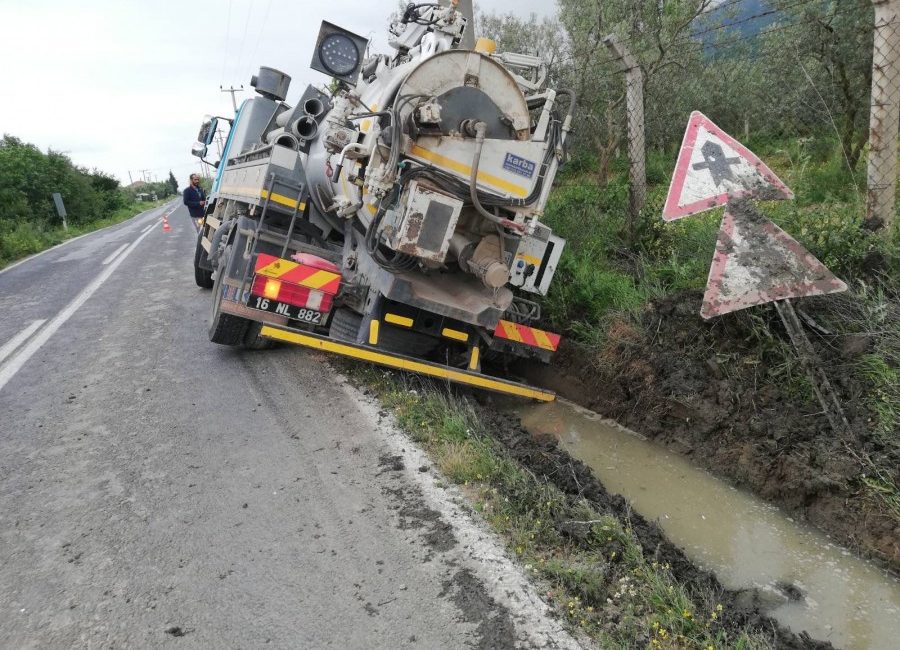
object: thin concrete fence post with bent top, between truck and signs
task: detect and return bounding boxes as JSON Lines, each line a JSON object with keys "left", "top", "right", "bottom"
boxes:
{"left": 603, "top": 34, "right": 647, "bottom": 244}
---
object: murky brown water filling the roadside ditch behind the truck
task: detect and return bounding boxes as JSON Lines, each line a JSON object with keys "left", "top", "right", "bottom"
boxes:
{"left": 518, "top": 401, "right": 900, "bottom": 650}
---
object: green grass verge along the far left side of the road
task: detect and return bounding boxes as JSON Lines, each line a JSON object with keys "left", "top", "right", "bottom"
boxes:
{"left": 0, "top": 199, "right": 169, "bottom": 268}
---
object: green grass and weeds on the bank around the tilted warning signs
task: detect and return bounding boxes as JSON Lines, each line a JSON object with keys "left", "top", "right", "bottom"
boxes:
{"left": 543, "top": 138, "right": 900, "bottom": 416}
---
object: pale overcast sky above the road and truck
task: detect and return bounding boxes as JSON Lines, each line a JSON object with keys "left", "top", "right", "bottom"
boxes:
{"left": 0, "top": 0, "right": 555, "bottom": 186}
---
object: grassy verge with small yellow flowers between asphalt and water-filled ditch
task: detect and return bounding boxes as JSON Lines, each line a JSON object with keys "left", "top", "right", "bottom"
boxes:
{"left": 347, "top": 365, "right": 768, "bottom": 649}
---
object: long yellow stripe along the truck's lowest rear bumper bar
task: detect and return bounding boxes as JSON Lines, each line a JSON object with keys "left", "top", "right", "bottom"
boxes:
{"left": 260, "top": 325, "right": 556, "bottom": 402}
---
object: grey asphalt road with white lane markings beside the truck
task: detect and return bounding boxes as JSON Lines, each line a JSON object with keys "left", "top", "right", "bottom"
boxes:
{"left": 0, "top": 208, "right": 575, "bottom": 648}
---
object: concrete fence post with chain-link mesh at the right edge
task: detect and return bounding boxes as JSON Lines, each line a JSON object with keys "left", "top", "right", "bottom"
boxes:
{"left": 866, "top": 0, "right": 900, "bottom": 235}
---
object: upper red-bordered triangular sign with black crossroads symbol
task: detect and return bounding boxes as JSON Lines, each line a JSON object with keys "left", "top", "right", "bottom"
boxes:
{"left": 663, "top": 111, "right": 794, "bottom": 221}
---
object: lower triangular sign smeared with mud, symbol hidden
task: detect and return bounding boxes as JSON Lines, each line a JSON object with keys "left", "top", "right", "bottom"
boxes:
{"left": 700, "top": 200, "right": 847, "bottom": 319}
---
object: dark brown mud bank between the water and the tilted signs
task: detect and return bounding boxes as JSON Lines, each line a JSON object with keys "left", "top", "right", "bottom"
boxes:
{"left": 514, "top": 292, "right": 900, "bottom": 574}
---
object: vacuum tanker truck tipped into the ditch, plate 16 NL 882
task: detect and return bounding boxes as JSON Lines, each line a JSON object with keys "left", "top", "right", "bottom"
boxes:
{"left": 193, "top": 2, "right": 575, "bottom": 400}
